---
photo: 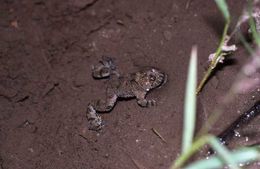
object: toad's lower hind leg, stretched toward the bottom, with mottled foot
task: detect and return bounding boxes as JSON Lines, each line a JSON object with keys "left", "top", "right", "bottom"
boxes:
{"left": 87, "top": 94, "right": 117, "bottom": 131}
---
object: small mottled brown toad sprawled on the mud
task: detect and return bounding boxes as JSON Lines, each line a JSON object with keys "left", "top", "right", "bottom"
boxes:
{"left": 87, "top": 57, "right": 167, "bottom": 131}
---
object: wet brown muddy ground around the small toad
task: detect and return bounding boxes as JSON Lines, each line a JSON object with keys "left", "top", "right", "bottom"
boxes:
{"left": 0, "top": 0, "right": 260, "bottom": 169}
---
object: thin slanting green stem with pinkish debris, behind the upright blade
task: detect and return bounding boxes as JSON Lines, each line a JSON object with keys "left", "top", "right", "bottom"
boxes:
{"left": 196, "top": 20, "right": 230, "bottom": 94}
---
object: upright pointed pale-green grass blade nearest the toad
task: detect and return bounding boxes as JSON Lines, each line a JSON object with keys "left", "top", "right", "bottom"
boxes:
{"left": 182, "top": 46, "right": 197, "bottom": 153}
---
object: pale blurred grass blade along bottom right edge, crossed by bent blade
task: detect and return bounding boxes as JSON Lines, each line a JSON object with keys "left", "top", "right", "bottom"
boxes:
{"left": 185, "top": 147, "right": 260, "bottom": 169}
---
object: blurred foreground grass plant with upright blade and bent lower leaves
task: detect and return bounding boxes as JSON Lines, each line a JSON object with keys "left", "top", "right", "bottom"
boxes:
{"left": 171, "top": 47, "right": 260, "bottom": 169}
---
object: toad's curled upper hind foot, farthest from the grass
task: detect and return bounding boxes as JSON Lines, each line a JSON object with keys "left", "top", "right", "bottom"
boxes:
{"left": 92, "top": 56, "right": 116, "bottom": 79}
